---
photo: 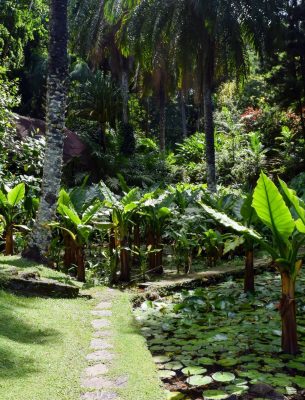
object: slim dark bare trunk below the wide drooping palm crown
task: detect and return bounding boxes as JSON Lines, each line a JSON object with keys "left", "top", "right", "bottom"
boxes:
{"left": 204, "top": 86, "right": 217, "bottom": 193}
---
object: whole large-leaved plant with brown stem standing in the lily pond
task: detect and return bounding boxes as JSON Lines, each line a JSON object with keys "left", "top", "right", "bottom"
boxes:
{"left": 200, "top": 172, "right": 305, "bottom": 354}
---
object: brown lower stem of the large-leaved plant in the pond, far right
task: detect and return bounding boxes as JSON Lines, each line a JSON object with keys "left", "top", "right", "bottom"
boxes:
{"left": 279, "top": 272, "right": 299, "bottom": 354}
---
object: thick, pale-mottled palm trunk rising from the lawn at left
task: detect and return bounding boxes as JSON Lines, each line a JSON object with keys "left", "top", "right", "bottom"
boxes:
{"left": 23, "top": 0, "right": 68, "bottom": 262}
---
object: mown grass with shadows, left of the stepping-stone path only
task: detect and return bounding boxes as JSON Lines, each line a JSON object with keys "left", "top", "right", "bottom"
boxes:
{"left": 0, "top": 290, "right": 92, "bottom": 400}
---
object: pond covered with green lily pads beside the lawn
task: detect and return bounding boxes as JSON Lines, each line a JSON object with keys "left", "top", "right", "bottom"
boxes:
{"left": 135, "top": 272, "right": 305, "bottom": 400}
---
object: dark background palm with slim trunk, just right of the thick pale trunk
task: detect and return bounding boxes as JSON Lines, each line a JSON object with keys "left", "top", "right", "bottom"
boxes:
{"left": 70, "top": 0, "right": 135, "bottom": 154}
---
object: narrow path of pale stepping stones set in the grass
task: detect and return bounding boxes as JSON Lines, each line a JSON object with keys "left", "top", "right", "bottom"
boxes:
{"left": 81, "top": 289, "right": 128, "bottom": 400}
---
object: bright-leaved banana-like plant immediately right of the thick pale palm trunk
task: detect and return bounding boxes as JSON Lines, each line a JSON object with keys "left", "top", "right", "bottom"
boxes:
{"left": 49, "top": 189, "right": 102, "bottom": 282}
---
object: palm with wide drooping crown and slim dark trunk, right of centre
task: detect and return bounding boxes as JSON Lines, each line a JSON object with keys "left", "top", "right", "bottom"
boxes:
{"left": 107, "top": 0, "right": 281, "bottom": 192}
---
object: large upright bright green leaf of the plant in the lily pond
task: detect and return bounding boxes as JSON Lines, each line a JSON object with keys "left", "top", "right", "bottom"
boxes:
{"left": 252, "top": 172, "right": 295, "bottom": 241}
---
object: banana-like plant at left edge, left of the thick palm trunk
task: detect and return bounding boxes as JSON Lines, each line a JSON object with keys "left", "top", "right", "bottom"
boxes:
{"left": 0, "top": 183, "right": 27, "bottom": 255}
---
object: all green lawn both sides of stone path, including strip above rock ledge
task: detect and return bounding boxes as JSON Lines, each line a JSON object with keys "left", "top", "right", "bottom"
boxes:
{"left": 0, "top": 256, "right": 165, "bottom": 400}
